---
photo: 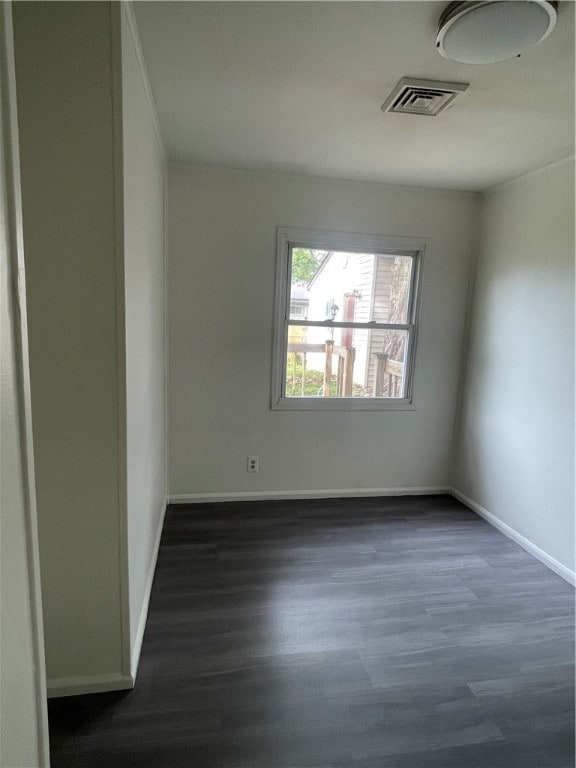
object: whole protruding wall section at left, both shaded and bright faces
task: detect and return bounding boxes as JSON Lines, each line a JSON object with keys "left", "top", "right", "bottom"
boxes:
{"left": 15, "top": 3, "right": 166, "bottom": 694}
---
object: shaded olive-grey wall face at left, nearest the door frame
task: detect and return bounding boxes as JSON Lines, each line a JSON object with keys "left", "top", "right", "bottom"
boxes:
{"left": 14, "top": 2, "right": 131, "bottom": 693}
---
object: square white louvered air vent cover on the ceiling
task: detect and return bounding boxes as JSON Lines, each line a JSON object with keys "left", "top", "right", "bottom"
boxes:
{"left": 380, "top": 77, "right": 470, "bottom": 116}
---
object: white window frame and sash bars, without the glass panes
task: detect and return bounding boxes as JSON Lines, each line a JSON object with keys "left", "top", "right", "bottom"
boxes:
{"left": 270, "top": 227, "right": 428, "bottom": 411}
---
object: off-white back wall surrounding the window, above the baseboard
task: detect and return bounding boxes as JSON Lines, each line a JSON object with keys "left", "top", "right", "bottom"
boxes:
{"left": 168, "top": 164, "right": 476, "bottom": 497}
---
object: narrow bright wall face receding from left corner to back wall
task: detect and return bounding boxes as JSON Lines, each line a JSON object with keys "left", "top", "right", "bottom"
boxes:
{"left": 122, "top": 4, "right": 166, "bottom": 674}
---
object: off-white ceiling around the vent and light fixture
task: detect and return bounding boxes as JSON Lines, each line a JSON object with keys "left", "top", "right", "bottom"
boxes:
{"left": 134, "top": 0, "right": 574, "bottom": 190}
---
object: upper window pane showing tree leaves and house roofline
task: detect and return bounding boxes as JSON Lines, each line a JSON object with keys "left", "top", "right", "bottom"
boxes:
{"left": 290, "top": 248, "right": 413, "bottom": 323}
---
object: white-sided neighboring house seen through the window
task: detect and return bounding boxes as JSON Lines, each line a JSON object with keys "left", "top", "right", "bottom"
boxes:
{"left": 304, "top": 252, "right": 404, "bottom": 395}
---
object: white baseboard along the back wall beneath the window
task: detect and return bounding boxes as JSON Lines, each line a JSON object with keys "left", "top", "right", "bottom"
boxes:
{"left": 168, "top": 485, "right": 450, "bottom": 504}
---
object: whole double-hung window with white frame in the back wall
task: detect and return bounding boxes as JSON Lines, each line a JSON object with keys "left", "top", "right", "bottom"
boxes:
{"left": 272, "top": 229, "right": 425, "bottom": 410}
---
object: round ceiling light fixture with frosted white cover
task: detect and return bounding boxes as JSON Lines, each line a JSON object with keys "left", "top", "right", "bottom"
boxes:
{"left": 436, "top": 0, "right": 558, "bottom": 64}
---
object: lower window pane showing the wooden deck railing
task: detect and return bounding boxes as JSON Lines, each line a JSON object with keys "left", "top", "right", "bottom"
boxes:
{"left": 285, "top": 326, "right": 408, "bottom": 398}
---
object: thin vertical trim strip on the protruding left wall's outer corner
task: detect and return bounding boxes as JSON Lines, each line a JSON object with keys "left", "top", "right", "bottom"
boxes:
{"left": 110, "top": 3, "right": 131, "bottom": 676}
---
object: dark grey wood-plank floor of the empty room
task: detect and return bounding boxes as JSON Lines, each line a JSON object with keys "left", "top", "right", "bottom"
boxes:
{"left": 49, "top": 496, "right": 574, "bottom": 768}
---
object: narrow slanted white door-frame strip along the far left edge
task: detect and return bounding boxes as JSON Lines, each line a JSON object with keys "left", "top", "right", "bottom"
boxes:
{"left": 0, "top": 2, "right": 50, "bottom": 768}
